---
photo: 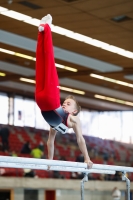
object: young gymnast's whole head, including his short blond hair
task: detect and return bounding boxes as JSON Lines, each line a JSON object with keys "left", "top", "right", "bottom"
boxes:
{"left": 62, "top": 95, "right": 81, "bottom": 116}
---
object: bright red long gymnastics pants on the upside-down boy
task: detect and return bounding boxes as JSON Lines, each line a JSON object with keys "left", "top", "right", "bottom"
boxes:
{"left": 35, "top": 24, "right": 60, "bottom": 111}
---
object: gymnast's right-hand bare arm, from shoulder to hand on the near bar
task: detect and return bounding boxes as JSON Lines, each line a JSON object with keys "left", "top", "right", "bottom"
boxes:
{"left": 68, "top": 115, "right": 93, "bottom": 168}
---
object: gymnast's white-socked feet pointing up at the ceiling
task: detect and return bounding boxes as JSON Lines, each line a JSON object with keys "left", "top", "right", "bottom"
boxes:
{"left": 38, "top": 14, "right": 52, "bottom": 32}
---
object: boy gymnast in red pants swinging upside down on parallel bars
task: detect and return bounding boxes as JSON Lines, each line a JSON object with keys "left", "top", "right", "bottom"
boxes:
{"left": 35, "top": 15, "right": 93, "bottom": 168}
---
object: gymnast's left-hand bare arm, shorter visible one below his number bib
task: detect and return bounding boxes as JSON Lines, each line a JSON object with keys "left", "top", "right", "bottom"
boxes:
{"left": 47, "top": 128, "right": 57, "bottom": 160}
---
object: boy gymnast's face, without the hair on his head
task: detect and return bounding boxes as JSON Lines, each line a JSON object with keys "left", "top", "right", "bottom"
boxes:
{"left": 62, "top": 99, "right": 77, "bottom": 115}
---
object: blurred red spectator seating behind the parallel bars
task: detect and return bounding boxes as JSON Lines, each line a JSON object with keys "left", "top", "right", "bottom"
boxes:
{"left": 0, "top": 126, "right": 133, "bottom": 178}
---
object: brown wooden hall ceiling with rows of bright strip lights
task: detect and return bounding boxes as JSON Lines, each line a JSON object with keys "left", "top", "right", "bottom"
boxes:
{"left": 0, "top": 0, "right": 133, "bottom": 110}
